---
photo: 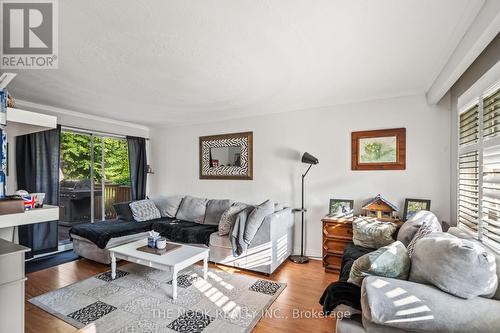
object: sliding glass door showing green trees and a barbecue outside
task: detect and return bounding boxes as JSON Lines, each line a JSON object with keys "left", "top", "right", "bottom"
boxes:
{"left": 59, "top": 129, "right": 131, "bottom": 244}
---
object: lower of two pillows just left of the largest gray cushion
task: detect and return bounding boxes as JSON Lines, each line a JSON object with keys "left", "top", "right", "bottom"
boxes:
{"left": 347, "top": 241, "right": 410, "bottom": 287}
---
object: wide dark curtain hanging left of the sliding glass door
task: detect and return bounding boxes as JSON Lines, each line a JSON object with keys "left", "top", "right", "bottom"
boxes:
{"left": 16, "top": 126, "right": 61, "bottom": 257}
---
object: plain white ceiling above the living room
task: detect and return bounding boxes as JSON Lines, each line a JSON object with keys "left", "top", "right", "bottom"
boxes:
{"left": 6, "top": 0, "right": 483, "bottom": 126}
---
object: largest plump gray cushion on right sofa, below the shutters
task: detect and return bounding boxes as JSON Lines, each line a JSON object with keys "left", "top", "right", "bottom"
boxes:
{"left": 410, "top": 232, "right": 498, "bottom": 299}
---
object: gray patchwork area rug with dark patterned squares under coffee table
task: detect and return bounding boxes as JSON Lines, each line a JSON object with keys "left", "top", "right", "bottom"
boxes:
{"left": 29, "top": 264, "right": 286, "bottom": 333}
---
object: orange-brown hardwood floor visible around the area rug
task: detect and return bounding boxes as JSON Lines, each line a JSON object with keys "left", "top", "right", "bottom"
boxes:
{"left": 25, "top": 259, "right": 338, "bottom": 333}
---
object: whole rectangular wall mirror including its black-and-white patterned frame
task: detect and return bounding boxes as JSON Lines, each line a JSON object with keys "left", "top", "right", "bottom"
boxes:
{"left": 200, "top": 132, "right": 253, "bottom": 180}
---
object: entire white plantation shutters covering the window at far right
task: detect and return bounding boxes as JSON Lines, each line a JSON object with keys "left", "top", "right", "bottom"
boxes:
{"left": 457, "top": 82, "right": 500, "bottom": 251}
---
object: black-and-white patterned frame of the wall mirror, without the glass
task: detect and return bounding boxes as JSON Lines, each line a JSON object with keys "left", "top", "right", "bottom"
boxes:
{"left": 200, "top": 132, "right": 253, "bottom": 180}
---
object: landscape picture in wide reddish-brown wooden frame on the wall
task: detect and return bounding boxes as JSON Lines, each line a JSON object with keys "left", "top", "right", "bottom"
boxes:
{"left": 351, "top": 128, "right": 406, "bottom": 170}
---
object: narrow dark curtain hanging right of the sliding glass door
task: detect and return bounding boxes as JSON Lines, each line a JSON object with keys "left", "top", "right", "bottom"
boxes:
{"left": 127, "top": 136, "right": 147, "bottom": 200}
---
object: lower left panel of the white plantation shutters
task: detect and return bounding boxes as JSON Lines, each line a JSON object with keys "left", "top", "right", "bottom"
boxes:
{"left": 458, "top": 151, "right": 479, "bottom": 233}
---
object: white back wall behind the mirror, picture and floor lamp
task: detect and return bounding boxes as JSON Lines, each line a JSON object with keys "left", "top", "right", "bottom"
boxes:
{"left": 150, "top": 95, "right": 450, "bottom": 257}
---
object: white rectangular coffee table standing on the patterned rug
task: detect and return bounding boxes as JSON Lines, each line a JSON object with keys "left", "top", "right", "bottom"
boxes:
{"left": 109, "top": 238, "right": 209, "bottom": 299}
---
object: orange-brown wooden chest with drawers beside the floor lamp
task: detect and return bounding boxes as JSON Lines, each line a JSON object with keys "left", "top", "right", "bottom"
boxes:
{"left": 321, "top": 217, "right": 353, "bottom": 274}
